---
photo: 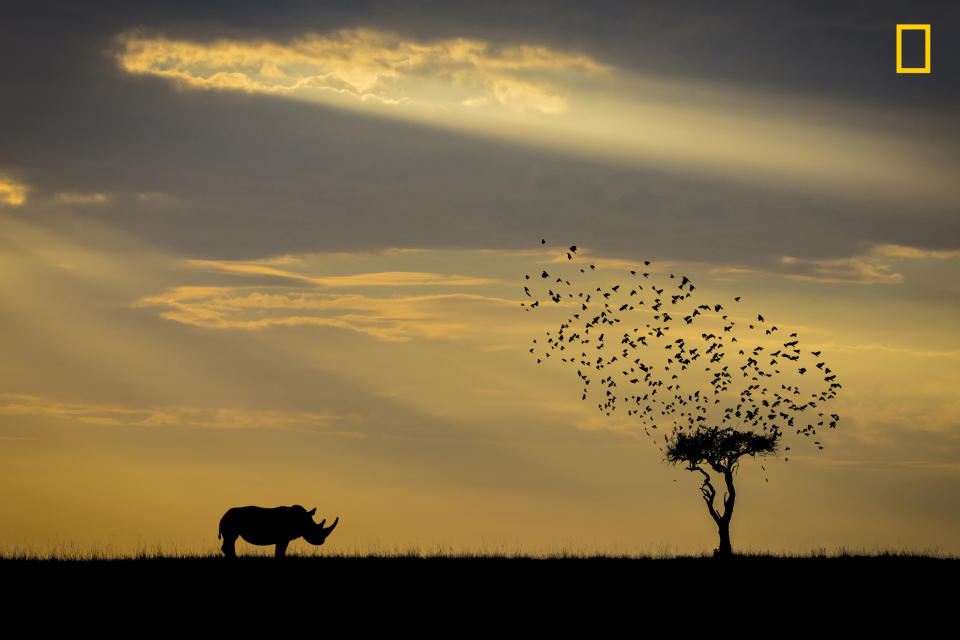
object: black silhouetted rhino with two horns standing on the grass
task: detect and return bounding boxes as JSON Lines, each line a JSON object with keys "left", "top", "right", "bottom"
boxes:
{"left": 217, "top": 505, "right": 340, "bottom": 558}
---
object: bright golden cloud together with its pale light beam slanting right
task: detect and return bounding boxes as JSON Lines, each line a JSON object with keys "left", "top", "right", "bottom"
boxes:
{"left": 116, "top": 28, "right": 956, "bottom": 206}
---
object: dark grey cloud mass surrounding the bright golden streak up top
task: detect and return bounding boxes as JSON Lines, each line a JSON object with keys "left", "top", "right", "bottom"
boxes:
{"left": 0, "top": 2, "right": 960, "bottom": 264}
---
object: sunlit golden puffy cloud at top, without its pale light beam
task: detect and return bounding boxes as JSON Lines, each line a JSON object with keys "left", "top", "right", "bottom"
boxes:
{"left": 117, "top": 29, "right": 607, "bottom": 114}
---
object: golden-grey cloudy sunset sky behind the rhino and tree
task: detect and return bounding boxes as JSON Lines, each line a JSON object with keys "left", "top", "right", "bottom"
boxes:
{"left": 0, "top": 1, "right": 960, "bottom": 554}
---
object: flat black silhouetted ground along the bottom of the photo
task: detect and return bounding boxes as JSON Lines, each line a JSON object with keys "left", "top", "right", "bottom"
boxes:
{"left": 0, "top": 556, "right": 960, "bottom": 637}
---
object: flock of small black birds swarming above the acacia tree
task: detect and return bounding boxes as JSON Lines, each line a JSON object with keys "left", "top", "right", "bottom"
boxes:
{"left": 521, "top": 240, "right": 841, "bottom": 459}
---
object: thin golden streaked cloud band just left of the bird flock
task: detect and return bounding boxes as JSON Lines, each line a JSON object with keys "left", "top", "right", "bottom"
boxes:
{"left": 133, "top": 249, "right": 543, "bottom": 344}
